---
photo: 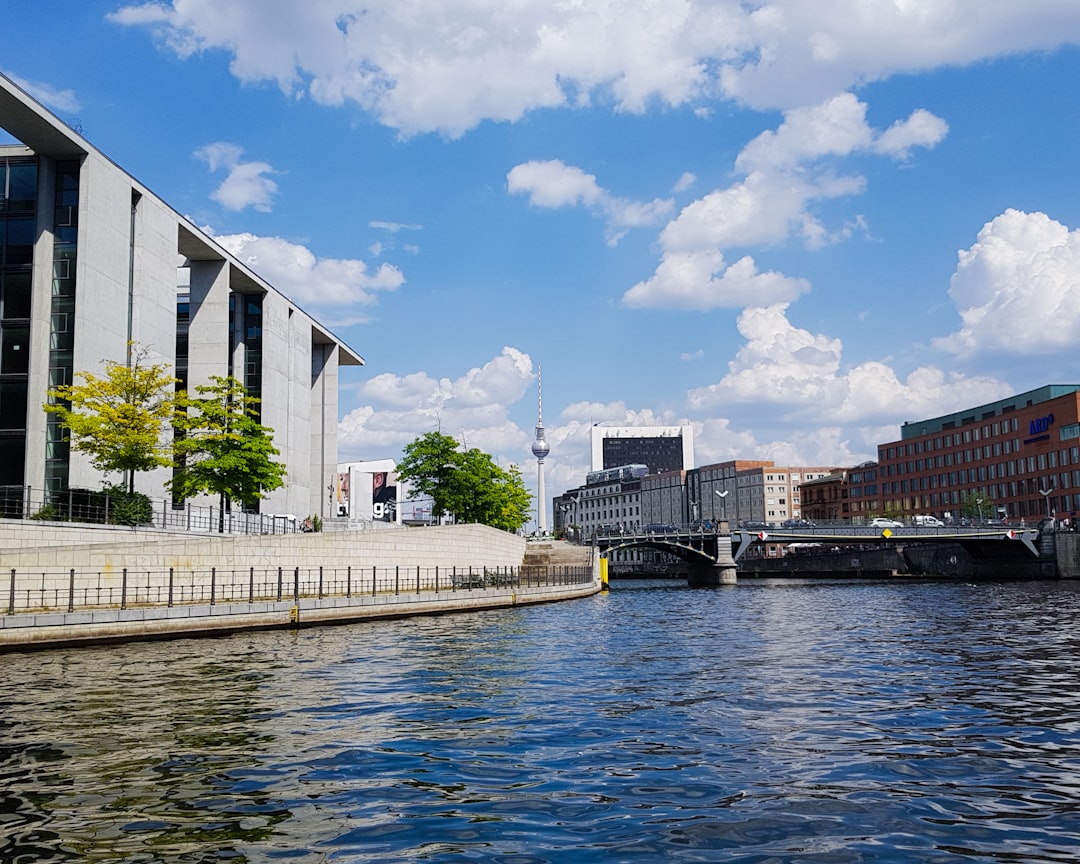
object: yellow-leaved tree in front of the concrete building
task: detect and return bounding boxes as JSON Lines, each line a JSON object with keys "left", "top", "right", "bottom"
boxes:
{"left": 42, "top": 347, "right": 176, "bottom": 494}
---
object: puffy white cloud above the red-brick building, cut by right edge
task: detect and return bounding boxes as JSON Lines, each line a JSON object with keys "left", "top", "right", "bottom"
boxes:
{"left": 934, "top": 210, "right": 1080, "bottom": 358}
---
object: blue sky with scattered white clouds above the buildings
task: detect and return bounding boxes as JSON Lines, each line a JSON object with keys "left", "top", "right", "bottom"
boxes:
{"left": 6, "top": 0, "right": 1080, "bottom": 522}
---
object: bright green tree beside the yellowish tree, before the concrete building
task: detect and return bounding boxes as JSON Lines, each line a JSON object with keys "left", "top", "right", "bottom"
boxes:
{"left": 168, "top": 375, "right": 285, "bottom": 522}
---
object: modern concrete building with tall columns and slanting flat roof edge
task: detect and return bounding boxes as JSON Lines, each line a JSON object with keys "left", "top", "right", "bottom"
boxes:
{"left": 0, "top": 76, "right": 364, "bottom": 516}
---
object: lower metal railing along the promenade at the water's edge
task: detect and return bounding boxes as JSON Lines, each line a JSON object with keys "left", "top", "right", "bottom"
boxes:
{"left": 3, "top": 566, "right": 593, "bottom": 615}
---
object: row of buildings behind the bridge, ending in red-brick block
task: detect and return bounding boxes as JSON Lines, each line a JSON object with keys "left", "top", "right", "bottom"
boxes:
{"left": 552, "top": 384, "right": 1080, "bottom": 536}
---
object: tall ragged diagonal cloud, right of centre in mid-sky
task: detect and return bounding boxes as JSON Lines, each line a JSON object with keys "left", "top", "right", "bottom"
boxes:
{"left": 623, "top": 93, "right": 947, "bottom": 310}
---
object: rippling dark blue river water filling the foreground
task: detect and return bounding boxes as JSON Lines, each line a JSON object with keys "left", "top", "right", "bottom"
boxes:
{"left": 0, "top": 580, "right": 1080, "bottom": 864}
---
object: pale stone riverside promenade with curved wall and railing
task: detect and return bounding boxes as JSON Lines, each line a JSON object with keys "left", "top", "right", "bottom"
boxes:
{"left": 0, "top": 521, "right": 600, "bottom": 651}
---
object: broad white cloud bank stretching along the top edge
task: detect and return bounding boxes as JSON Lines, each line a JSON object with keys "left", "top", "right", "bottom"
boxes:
{"left": 109, "top": 0, "right": 1080, "bottom": 136}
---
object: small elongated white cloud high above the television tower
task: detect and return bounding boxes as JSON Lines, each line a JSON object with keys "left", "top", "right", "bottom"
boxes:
{"left": 507, "top": 159, "right": 674, "bottom": 245}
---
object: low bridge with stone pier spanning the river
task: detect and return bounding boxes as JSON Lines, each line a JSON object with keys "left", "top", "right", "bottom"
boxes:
{"left": 592, "top": 525, "right": 1040, "bottom": 586}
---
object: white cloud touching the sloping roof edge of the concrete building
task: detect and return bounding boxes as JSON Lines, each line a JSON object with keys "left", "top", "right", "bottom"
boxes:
{"left": 214, "top": 228, "right": 405, "bottom": 313}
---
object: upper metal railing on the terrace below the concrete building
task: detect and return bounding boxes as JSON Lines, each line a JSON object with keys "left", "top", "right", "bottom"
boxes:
{"left": 0, "top": 486, "right": 302, "bottom": 535}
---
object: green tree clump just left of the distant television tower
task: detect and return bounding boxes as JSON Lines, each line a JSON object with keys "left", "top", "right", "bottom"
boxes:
{"left": 397, "top": 432, "right": 531, "bottom": 531}
